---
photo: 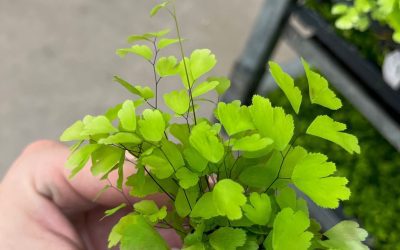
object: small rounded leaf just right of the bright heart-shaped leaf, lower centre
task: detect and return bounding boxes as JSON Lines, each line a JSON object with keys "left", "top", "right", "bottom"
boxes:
{"left": 243, "top": 192, "right": 272, "bottom": 226}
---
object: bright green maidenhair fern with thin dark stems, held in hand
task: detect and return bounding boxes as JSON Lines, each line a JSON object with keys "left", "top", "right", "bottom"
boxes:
{"left": 60, "top": 1, "right": 368, "bottom": 250}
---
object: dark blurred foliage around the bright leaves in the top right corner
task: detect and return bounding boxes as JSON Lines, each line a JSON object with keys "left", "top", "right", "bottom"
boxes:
{"left": 306, "top": 0, "right": 399, "bottom": 66}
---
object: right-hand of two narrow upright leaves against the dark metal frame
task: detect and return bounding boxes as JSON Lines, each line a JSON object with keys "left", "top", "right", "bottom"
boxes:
{"left": 301, "top": 59, "right": 342, "bottom": 110}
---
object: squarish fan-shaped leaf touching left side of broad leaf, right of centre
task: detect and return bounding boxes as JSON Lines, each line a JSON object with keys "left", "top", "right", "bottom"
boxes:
{"left": 217, "top": 101, "right": 254, "bottom": 136}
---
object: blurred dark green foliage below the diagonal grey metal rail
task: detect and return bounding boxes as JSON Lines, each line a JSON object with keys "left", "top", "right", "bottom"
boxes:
{"left": 268, "top": 73, "right": 400, "bottom": 250}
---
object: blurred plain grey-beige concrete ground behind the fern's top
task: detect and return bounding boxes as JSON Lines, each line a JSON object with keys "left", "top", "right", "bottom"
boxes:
{"left": 0, "top": 0, "right": 291, "bottom": 177}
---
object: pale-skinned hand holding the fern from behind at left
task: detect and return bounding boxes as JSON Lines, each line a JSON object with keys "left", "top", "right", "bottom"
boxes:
{"left": 0, "top": 141, "right": 181, "bottom": 250}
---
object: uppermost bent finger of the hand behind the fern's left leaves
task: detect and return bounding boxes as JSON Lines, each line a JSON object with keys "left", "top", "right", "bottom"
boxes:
{"left": 3, "top": 141, "right": 169, "bottom": 213}
